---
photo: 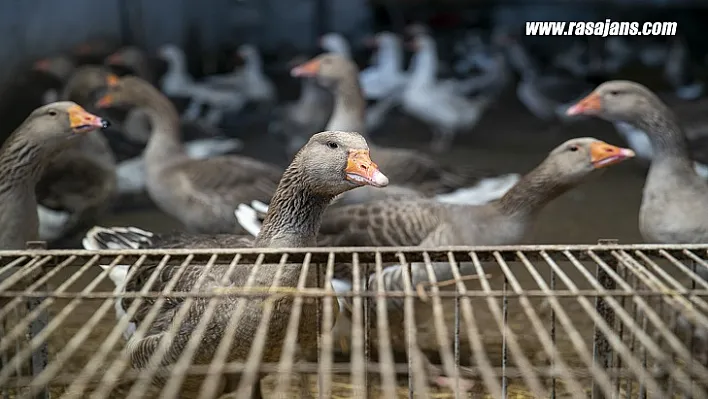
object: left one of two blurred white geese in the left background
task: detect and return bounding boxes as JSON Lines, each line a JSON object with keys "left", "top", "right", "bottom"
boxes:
{"left": 158, "top": 44, "right": 246, "bottom": 125}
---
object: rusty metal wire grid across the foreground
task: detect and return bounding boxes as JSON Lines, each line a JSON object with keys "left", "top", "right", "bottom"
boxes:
{"left": 0, "top": 244, "right": 708, "bottom": 398}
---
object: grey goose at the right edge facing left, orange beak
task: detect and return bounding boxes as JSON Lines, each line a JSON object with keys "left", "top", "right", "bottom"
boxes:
{"left": 568, "top": 80, "right": 708, "bottom": 384}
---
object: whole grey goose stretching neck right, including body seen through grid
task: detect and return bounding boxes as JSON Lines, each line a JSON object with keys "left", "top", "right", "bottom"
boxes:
{"left": 318, "top": 137, "right": 634, "bottom": 389}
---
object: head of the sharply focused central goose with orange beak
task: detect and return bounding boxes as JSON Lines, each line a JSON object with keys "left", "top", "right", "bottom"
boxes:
{"left": 293, "top": 131, "right": 388, "bottom": 196}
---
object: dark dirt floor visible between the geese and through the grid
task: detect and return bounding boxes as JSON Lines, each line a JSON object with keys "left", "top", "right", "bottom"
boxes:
{"left": 4, "top": 89, "right": 668, "bottom": 397}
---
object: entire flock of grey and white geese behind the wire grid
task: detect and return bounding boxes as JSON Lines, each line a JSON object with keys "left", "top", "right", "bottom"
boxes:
{"left": 0, "top": 27, "right": 708, "bottom": 397}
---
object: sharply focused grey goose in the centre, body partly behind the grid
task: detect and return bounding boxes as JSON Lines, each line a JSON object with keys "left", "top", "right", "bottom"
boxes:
{"left": 84, "top": 132, "right": 388, "bottom": 398}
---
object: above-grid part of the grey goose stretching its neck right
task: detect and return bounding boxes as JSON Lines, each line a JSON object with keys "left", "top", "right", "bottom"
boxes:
{"left": 318, "top": 137, "right": 634, "bottom": 248}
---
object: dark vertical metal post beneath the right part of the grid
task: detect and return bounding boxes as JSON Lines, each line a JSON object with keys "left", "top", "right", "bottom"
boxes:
{"left": 592, "top": 240, "right": 617, "bottom": 399}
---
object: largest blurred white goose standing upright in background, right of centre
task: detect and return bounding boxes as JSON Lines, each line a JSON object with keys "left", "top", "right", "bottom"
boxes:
{"left": 402, "top": 34, "right": 491, "bottom": 152}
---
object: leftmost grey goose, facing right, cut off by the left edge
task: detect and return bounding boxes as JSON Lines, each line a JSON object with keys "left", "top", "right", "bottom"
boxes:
{"left": 0, "top": 101, "right": 108, "bottom": 250}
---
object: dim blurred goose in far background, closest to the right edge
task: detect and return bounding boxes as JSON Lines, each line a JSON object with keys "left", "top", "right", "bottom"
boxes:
{"left": 664, "top": 37, "right": 704, "bottom": 100}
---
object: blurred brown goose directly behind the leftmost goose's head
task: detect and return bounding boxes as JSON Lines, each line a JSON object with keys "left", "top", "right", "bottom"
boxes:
{"left": 36, "top": 66, "right": 117, "bottom": 241}
